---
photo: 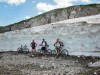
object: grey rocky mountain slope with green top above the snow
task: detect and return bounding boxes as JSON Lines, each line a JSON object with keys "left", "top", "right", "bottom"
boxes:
{"left": 0, "top": 4, "right": 100, "bottom": 33}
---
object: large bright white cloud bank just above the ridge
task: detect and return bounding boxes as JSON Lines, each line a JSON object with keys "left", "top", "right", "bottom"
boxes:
{"left": 36, "top": 0, "right": 91, "bottom": 12}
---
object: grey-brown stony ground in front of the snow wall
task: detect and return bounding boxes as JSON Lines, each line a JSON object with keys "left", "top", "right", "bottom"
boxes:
{"left": 0, "top": 52, "right": 100, "bottom": 75}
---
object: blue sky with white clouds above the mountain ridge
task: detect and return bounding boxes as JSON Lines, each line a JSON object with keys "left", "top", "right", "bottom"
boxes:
{"left": 0, "top": 0, "right": 100, "bottom": 26}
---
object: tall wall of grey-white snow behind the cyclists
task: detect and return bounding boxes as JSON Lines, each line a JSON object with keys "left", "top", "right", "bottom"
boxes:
{"left": 0, "top": 15, "right": 100, "bottom": 56}
